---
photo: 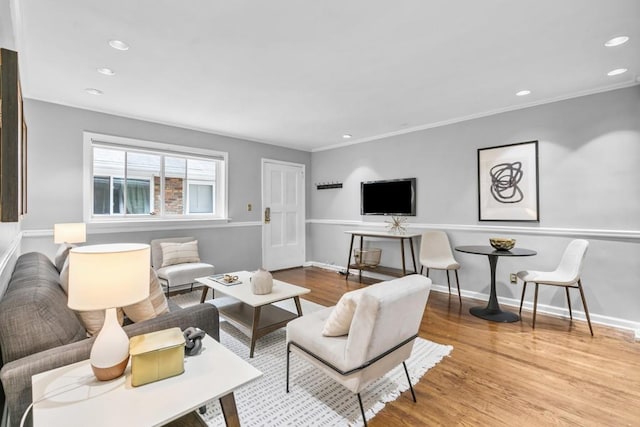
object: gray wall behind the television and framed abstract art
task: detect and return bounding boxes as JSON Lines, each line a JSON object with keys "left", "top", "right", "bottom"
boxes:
{"left": 307, "top": 86, "right": 640, "bottom": 328}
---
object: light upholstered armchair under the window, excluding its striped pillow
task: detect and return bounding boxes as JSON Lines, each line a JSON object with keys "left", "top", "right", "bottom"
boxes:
{"left": 151, "top": 237, "right": 215, "bottom": 297}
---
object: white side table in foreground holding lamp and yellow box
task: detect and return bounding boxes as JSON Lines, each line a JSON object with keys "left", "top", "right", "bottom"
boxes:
{"left": 31, "top": 336, "right": 262, "bottom": 427}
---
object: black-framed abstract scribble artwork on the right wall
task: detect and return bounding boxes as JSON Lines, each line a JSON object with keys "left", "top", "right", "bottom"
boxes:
{"left": 478, "top": 141, "right": 540, "bottom": 222}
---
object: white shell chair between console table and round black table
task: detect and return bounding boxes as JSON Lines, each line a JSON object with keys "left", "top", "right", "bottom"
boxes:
{"left": 420, "top": 231, "right": 462, "bottom": 305}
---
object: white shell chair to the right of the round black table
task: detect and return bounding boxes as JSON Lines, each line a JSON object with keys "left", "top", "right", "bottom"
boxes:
{"left": 518, "top": 239, "right": 593, "bottom": 336}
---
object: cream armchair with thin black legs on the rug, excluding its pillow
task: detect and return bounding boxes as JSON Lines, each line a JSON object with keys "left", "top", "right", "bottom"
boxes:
{"left": 287, "top": 274, "right": 431, "bottom": 425}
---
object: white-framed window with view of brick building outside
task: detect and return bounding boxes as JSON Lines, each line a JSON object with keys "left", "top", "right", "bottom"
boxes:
{"left": 85, "top": 133, "right": 227, "bottom": 221}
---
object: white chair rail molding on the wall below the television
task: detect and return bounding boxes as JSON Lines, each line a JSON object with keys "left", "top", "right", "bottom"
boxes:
{"left": 307, "top": 219, "right": 640, "bottom": 242}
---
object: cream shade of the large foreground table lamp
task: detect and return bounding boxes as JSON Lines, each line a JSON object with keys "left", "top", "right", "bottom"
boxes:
{"left": 68, "top": 243, "right": 151, "bottom": 311}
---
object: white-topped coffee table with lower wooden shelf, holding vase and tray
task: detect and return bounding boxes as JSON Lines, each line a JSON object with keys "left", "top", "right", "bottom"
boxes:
{"left": 196, "top": 271, "right": 310, "bottom": 358}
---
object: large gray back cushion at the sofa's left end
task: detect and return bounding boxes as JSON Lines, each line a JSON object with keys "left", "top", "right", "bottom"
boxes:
{"left": 0, "top": 252, "right": 86, "bottom": 363}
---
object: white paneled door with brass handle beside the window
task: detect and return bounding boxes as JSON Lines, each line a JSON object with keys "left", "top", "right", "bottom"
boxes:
{"left": 262, "top": 159, "right": 305, "bottom": 270}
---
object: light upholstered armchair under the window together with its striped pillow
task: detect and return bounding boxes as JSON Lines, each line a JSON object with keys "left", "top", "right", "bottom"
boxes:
{"left": 151, "top": 237, "right": 215, "bottom": 297}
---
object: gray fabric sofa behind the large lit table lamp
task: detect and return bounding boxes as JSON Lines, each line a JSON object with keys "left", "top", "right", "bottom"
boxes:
{"left": 0, "top": 252, "right": 219, "bottom": 427}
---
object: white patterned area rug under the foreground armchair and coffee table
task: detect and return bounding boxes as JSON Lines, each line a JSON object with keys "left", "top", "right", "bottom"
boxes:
{"left": 182, "top": 298, "right": 453, "bottom": 427}
